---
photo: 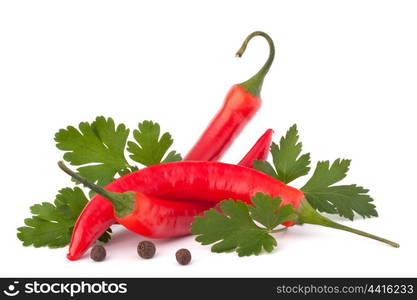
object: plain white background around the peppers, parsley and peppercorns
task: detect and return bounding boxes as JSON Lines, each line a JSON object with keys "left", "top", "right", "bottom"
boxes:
{"left": 0, "top": 0, "right": 417, "bottom": 277}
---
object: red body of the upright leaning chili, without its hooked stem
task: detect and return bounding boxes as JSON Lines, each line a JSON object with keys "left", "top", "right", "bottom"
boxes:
{"left": 184, "top": 85, "right": 261, "bottom": 161}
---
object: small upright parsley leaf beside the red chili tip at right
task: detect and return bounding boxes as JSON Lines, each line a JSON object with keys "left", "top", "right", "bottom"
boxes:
{"left": 254, "top": 124, "right": 310, "bottom": 183}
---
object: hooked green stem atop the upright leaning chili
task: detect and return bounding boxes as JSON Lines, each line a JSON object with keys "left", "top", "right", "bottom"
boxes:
{"left": 236, "top": 31, "right": 275, "bottom": 97}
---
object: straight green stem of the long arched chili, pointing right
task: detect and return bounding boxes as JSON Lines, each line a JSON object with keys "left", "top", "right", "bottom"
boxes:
{"left": 297, "top": 199, "right": 400, "bottom": 248}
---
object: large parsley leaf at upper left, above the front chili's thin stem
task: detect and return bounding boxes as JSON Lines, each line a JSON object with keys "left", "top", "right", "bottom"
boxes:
{"left": 55, "top": 117, "right": 130, "bottom": 186}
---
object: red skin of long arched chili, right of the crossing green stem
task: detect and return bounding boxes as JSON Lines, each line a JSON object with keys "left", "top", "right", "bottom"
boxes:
{"left": 116, "top": 161, "right": 304, "bottom": 207}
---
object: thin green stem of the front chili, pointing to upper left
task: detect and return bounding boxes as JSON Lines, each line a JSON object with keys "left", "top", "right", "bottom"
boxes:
{"left": 58, "top": 161, "right": 135, "bottom": 218}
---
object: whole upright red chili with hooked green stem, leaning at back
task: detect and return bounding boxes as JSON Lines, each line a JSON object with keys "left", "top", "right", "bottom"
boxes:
{"left": 184, "top": 31, "right": 275, "bottom": 161}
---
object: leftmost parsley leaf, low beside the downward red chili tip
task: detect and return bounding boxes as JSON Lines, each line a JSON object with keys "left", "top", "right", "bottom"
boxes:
{"left": 17, "top": 187, "right": 88, "bottom": 248}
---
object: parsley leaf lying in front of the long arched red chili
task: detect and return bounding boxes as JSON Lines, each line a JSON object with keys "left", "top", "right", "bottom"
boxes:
{"left": 191, "top": 193, "right": 296, "bottom": 256}
